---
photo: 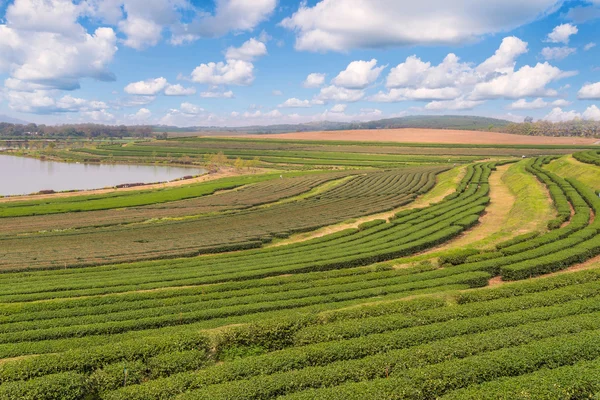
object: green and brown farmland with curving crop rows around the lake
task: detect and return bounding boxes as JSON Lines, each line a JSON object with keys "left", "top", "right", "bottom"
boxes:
{"left": 0, "top": 137, "right": 600, "bottom": 400}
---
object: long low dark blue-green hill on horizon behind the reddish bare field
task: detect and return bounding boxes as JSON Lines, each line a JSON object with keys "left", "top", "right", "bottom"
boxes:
{"left": 154, "top": 115, "right": 511, "bottom": 134}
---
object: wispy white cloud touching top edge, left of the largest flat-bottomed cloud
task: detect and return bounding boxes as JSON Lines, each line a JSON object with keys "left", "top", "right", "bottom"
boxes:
{"left": 172, "top": 0, "right": 277, "bottom": 44}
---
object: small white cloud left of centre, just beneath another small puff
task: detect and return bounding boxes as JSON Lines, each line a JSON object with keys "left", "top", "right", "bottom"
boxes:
{"left": 192, "top": 60, "right": 254, "bottom": 86}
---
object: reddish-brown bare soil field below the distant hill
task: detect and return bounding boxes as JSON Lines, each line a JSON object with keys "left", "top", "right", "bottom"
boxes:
{"left": 238, "top": 129, "right": 598, "bottom": 145}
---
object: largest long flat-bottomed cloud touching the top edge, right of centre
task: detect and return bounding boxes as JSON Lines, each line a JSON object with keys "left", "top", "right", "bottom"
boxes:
{"left": 281, "top": 0, "right": 557, "bottom": 51}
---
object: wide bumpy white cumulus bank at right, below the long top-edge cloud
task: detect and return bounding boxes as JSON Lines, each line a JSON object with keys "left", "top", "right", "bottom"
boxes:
{"left": 370, "top": 36, "right": 573, "bottom": 103}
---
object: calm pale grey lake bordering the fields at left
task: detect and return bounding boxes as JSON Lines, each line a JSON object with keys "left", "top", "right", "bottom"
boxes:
{"left": 0, "top": 154, "right": 206, "bottom": 196}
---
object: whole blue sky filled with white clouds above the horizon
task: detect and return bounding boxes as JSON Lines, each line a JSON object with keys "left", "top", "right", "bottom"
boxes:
{"left": 0, "top": 0, "right": 600, "bottom": 126}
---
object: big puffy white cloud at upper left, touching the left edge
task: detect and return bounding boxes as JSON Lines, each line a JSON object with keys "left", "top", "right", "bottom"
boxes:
{"left": 0, "top": 14, "right": 117, "bottom": 90}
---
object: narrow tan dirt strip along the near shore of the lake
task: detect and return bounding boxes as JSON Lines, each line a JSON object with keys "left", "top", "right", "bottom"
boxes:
{"left": 0, "top": 168, "right": 264, "bottom": 203}
